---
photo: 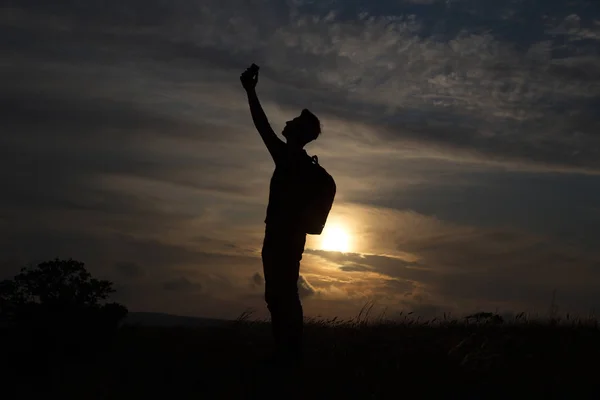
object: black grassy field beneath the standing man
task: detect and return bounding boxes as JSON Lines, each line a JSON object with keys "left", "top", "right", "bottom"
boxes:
{"left": 2, "top": 317, "right": 600, "bottom": 399}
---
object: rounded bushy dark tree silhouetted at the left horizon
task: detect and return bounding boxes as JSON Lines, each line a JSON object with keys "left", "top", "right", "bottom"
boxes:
{"left": 0, "top": 258, "right": 127, "bottom": 350}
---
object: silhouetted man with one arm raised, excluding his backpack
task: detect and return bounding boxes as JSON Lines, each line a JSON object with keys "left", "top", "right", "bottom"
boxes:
{"left": 240, "top": 64, "right": 324, "bottom": 361}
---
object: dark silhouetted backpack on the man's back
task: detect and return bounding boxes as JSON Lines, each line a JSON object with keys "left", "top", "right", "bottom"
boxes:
{"left": 302, "top": 156, "right": 336, "bottom": 235}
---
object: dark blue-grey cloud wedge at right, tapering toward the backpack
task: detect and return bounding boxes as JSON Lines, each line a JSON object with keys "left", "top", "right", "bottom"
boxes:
{"left": 350, "top": 171, "right": 600, "bottom": 249}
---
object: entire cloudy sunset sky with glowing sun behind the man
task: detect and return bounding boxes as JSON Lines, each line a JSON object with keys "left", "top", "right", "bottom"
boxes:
{"left": 0, "top": 0, "right": 600, "bottom": 318}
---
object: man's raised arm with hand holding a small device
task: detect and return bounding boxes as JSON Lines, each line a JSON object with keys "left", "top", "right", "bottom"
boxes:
{"left": 240, "top": 64, "right": 285, "bottom": 162}
